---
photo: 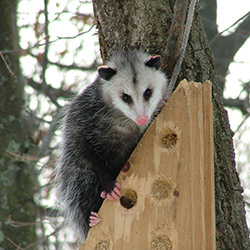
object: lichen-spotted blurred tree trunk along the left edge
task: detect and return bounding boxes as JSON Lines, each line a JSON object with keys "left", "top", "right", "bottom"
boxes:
{"left": 0, "top": 0, "right": 36, "bottom": 250}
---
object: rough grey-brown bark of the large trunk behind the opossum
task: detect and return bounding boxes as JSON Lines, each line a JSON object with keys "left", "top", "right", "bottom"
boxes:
{"left": 93, "top": 0, "right": 250, "bottom": 250}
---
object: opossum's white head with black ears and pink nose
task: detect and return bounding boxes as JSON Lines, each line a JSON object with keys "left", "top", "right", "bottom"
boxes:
{"left": 98, "top": 50, "right": 167, "bottom": 126}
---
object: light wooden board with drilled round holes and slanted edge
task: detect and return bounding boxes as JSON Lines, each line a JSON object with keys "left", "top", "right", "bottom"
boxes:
{"left": 80, "top": 80, "right": 216, "bottom": 250}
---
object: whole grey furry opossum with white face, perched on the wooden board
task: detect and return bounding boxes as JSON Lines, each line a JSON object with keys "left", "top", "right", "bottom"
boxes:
{"left": 55, "top": 51, "right": 167, "bottom": 242}
